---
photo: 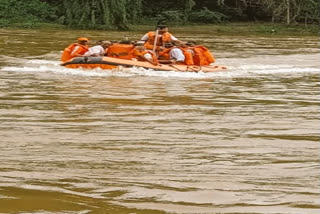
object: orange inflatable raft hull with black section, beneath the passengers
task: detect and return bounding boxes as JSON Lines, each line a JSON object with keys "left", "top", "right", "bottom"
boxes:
{"left": 61, "top": 57, "right": 227, "bottom": 73}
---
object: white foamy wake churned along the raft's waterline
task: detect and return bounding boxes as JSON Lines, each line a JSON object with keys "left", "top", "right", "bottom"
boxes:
{"left": 0, "top": 54, "right": 320, "bottom": 79}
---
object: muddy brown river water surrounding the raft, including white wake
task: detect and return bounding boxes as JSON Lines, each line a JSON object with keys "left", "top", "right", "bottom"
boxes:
{"left": 0, "top": 29, "right": 320, "bottom": 214}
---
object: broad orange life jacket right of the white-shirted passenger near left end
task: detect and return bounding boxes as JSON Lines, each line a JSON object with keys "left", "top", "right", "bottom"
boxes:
{"left": 107, "top": 43, "right": 134, "bottom": 59}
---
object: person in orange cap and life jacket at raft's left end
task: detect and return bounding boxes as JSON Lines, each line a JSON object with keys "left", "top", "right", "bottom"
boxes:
{"left": 61, "top": 37, "right": 89, "bottom": 62}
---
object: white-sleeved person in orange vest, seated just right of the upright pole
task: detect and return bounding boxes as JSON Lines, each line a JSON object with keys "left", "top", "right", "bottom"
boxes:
{"left": 159, "top": 42, "right": 186, "bottom": 64}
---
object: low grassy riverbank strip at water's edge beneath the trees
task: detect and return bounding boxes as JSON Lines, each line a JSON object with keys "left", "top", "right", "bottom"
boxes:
{"left": 2, "top": 22, "right": 319, "bottom": 36}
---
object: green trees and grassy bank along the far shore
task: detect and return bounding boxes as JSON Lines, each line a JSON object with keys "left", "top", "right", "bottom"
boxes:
{"left": 0, "top": 0, "right": 320, "bottom": 35}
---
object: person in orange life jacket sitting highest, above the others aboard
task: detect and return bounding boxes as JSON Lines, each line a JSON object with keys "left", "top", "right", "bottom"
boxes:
{"left": 140, "top": 25, "right": 178, "bottom": 51}
